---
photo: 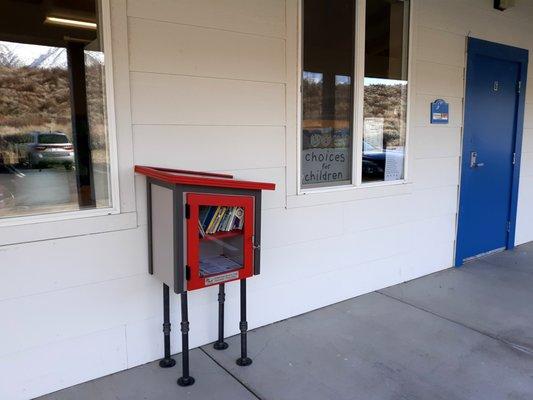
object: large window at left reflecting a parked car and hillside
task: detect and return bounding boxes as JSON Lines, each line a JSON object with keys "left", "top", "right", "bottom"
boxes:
{"left": 0, "top": 0, "right": 113, "bottom": 218}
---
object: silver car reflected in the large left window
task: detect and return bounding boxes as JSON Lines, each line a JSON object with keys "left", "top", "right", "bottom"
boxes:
{"left": 19, "top": 132, "right": 74, "bottom": 170}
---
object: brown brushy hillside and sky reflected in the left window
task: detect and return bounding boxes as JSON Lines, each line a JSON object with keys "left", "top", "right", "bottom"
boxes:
{"left": 0, "top": 42, "right": 106, "bottom": 162}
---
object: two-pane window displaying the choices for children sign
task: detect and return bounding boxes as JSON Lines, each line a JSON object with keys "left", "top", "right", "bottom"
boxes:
{"left": 300, "top": 0, "right": 410, "bottom": 189}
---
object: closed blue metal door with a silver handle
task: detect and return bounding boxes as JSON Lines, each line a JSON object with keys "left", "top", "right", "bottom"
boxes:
{"left": 456, "top": 39, "right": 522, "bottom": 266}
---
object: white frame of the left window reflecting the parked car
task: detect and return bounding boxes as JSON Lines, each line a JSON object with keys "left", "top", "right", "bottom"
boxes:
{"left": 0, "top": 0, "right": 121, "bottom": 227}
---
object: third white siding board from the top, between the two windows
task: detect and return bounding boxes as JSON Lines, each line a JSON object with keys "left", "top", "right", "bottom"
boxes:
{"left": 131, "top": 72, "right": 285, "bottom": 125}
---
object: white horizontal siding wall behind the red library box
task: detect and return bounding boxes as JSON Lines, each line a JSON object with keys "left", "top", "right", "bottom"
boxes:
{"left": 0, "top": 0, "right": 533, "bottom": 399}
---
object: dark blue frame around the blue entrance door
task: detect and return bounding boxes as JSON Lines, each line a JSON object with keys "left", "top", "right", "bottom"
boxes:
{"left": 454, "top": 37, "right": 529, "bottom": 267}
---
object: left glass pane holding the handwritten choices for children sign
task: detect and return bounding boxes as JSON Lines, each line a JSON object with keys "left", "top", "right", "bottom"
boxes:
{"left": 301, "top": 0, "right": 355, "bottom": 188}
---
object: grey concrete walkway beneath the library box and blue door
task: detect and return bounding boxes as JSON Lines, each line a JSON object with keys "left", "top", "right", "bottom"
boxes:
{"left": 41, "top": 244, "right": 533, "bottom": 400}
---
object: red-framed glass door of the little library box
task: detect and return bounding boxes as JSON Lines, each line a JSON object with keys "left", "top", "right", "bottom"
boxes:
{"left": 187, "top": 193, "right": 254, "bottom": 290}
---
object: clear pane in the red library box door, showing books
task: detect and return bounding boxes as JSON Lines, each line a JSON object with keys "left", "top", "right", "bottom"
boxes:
{"left": 198, "top": 205, "right": 244, "bottom": 277}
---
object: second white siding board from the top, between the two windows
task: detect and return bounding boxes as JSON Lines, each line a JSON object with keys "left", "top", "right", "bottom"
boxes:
{"left": 129, "top": 18, "right": 285, "bottom": 83}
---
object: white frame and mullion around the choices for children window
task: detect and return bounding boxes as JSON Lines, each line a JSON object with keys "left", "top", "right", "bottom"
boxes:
{"left": 296, "top": 0, "right": 416, "bottom": 195}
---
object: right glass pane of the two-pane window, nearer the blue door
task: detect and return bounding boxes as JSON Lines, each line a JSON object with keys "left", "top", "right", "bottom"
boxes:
{"left": 362, "top": 0, "right": 409, "bottom": 182}
